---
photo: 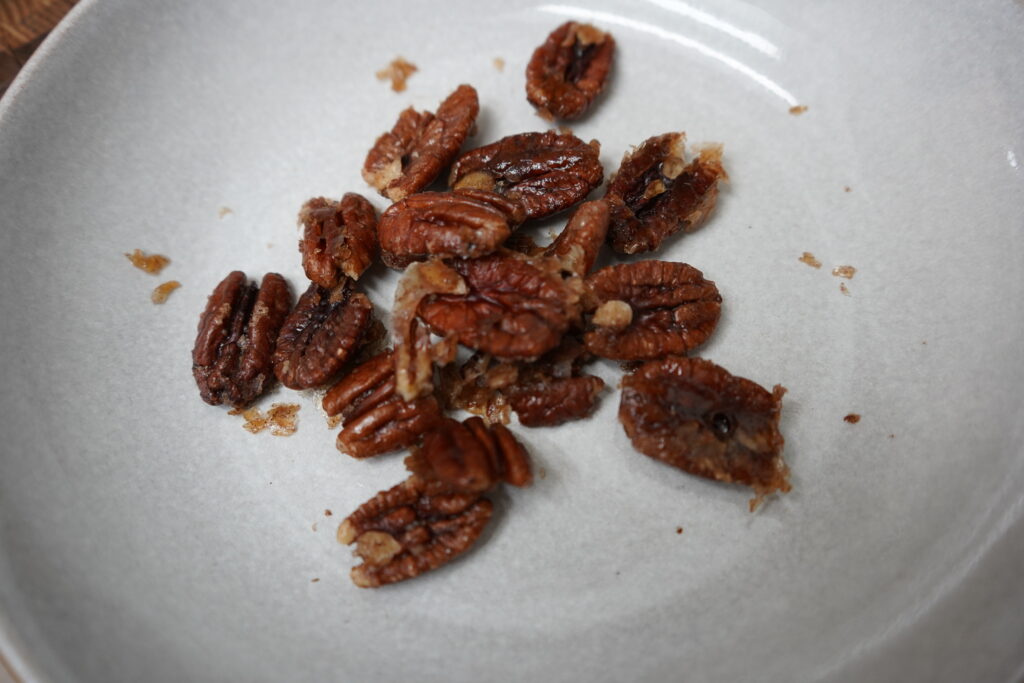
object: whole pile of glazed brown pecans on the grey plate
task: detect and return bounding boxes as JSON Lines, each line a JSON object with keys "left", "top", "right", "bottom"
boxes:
{"left": 193, "top": 22, "right": 790, "bottom": 587}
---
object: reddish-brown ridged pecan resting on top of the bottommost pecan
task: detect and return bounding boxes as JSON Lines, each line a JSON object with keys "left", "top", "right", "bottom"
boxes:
{"left": 406, "top": 416, "right": 534, "bottom": 493}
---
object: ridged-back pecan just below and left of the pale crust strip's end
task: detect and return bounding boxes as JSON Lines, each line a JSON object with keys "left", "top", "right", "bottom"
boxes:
{"left": 324, "top": 350, "right": 441, "bottom": 458}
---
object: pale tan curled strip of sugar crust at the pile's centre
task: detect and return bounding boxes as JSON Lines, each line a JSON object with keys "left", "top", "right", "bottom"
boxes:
{"left": 391, "top": 261, "right": 467, "bottom": 400}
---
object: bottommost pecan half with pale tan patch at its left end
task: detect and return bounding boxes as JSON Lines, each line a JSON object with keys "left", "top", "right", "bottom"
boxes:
{"left": 338, "top": 475, "right": 493, "bottom": 588}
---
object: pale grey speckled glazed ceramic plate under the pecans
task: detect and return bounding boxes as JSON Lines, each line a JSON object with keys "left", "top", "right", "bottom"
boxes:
{"left": 0, "top": 0, "right": 1024, "bottom": 683}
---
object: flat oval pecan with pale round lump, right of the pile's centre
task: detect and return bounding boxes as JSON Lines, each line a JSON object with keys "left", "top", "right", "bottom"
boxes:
{"left": 584, "top": 261, "right": 722, "bottom": 360}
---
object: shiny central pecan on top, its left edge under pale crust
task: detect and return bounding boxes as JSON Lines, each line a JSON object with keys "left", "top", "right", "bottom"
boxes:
{"left": 419, "top": 252, "right": 582, "bottom": 359}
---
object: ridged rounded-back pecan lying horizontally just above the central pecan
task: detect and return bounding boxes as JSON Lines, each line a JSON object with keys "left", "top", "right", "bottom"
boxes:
{"left": 378, "top": 189, "right": 523, "bottom": 269}
